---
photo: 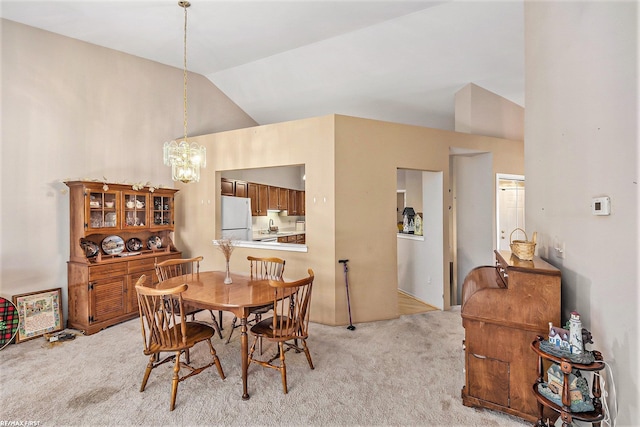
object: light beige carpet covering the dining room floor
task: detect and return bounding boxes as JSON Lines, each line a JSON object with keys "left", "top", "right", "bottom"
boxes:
{"left": 0, "top": 309, "right": 530, "bottom": 426}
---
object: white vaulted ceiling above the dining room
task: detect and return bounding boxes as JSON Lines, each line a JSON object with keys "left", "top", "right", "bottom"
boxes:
{"left": 0, "top": 0, "right": 524, "bottom": 129}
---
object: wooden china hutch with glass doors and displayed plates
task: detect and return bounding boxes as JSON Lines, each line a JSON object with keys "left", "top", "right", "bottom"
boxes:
{"left": 65, "top": 181, "right": 182, "bottom": 335}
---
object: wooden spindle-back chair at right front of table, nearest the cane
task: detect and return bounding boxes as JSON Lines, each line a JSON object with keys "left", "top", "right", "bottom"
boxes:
{"left": 249, "top": 269, "right": 314, "bottom": 394}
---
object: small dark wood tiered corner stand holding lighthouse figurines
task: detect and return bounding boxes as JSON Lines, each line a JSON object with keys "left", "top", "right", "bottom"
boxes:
{"left": 531, "top": 336, "right": 605, "bottom": 427}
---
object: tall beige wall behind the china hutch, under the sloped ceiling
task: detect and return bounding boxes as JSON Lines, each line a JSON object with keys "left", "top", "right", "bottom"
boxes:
{"left": 0, "top": 19, "right": 255, "bottom": 313}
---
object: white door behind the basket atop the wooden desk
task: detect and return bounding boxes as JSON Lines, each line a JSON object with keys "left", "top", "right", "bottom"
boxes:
{"left": 496, "top": 174, "right": 526, "bottom": 251}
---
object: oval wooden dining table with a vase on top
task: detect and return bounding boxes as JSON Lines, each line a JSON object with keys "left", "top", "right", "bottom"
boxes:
{"left": 157, "top": 271, "right": 286, "bottom": 400}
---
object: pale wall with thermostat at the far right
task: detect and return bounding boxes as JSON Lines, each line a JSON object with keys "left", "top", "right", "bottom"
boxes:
{"left": 525, "top": 2, "right": 640, "bottom": 426}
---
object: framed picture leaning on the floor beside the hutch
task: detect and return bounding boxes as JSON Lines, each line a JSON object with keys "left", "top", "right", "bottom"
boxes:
{"left": 13, "top": 288, "right": 62, "bottom": 343}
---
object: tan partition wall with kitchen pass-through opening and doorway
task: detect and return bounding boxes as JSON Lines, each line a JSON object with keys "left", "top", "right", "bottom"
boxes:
{"left": 185, "top": 115, "right": 524, "bottom": 325}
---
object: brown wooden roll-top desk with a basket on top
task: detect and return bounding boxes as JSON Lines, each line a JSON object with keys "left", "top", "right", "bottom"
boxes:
{"left": 461, "top": 251, "right": 561, "bottom": 422}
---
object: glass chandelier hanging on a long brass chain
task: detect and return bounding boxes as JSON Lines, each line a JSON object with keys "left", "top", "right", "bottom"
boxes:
{"left": 164, "top": 1, "right": 207, "bottom": 184}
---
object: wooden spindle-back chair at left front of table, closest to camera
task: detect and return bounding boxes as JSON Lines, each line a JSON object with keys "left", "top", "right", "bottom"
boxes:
{"left": 136, "top": 274, "right": 225, "bottom": 411}
